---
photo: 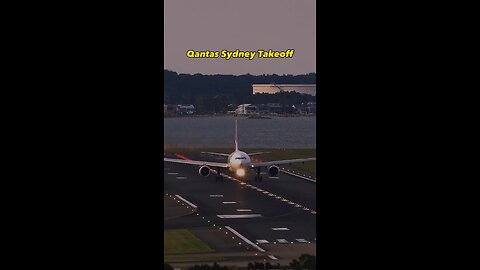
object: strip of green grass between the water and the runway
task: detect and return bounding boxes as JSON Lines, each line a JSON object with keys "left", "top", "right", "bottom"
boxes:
{"left": 164, "top": 148, "right": 317, "bottom": 176}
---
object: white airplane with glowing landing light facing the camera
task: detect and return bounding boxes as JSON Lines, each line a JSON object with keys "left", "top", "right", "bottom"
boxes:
{"left": 163, "top": 120, "right": 317, "bottom": 182}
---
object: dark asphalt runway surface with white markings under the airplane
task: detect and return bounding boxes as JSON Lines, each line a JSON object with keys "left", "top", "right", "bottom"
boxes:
{"left": 164, "top": 153, "right": 317, "bottom": 252}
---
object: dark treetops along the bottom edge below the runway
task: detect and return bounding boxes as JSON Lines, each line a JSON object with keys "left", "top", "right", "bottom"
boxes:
{"left": 163, "top": 254, "right": 317, "bottom": 270}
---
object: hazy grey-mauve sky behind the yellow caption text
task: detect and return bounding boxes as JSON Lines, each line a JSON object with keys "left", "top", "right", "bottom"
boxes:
{"left": 164, "top": 0, "right": 316, "bottom": 75}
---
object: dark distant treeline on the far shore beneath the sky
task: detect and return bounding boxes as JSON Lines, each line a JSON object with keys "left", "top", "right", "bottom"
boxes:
{"left": 164, "top": 70, "right": 316, "bottom": 113}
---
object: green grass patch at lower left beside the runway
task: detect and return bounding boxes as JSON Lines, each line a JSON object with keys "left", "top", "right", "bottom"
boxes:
{"left": 163, "top": 229, "right": 214, "bottom": 255}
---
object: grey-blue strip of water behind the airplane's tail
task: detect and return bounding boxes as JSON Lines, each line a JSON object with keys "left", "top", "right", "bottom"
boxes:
{"left": 163, "top": 116, "right": 316, "bottom": 149}
